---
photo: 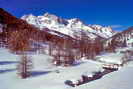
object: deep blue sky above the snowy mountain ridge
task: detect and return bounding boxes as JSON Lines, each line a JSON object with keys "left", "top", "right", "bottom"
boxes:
{"left": 0, "top": 0, "right": 133, "bottom": 30}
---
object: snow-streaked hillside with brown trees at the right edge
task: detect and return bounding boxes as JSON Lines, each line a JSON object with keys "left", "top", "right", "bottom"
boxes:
{"left": 106, "top": 27, "right": 133, "bottom": 47}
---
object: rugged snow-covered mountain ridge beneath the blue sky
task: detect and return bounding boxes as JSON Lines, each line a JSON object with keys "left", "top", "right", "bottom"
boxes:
{"left": 21, "top": 13, "right": 115, "bottom": 39}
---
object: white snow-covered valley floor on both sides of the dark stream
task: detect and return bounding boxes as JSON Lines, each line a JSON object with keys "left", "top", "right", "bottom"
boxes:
{"left": 0, "top": 48, "right": 133, "bottom": 89}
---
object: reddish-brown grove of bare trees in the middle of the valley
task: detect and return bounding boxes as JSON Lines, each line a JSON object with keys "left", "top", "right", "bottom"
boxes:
{"left": 49, "top": 31, "right": 103, "bottom": 66}
